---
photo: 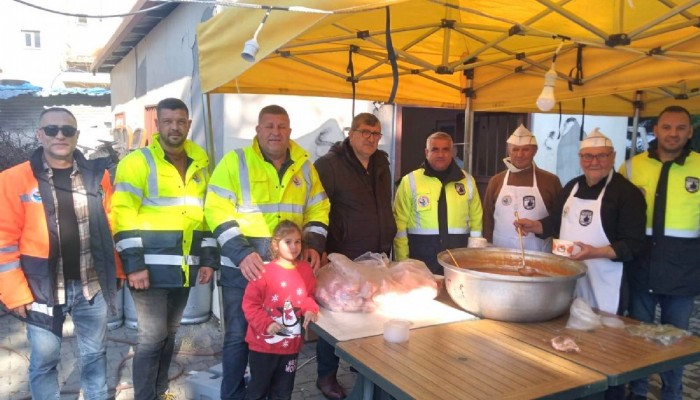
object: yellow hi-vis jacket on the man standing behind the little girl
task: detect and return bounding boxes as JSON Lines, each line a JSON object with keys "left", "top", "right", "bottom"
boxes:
{"left": 204, "top": 137, "right": 330, "bottom": 272}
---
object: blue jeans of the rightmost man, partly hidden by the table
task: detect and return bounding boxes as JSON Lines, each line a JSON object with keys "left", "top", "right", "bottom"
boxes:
{"left": 629, "top": 290, "right": 695, "bottom": 400}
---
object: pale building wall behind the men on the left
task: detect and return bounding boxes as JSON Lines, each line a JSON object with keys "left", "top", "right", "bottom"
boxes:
{"left": 106, "top": 4, "right": 395, "bottom": 167}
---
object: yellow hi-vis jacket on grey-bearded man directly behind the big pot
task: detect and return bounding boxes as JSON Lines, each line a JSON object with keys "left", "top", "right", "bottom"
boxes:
{"left": 394, "top": 166, "right": 482, "bottom": 260}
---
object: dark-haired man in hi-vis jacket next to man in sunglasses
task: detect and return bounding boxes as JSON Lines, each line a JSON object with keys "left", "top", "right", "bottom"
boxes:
{"left": 112, "top": 98, "right": 218, "bottom": 400}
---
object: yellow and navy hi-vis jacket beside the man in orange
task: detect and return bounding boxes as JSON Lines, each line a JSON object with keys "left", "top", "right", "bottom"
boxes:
{"left": 112, "top": 135, "right": 218, "bottom": 287}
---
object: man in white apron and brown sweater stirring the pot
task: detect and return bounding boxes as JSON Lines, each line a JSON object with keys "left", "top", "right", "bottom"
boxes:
{"left": 483, "top": 124, "right": 561, "bottom": 252}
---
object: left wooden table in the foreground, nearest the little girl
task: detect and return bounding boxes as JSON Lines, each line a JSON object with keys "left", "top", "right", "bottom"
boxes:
{"left": 336, "top": 321, "right": 607, "bottom": 400}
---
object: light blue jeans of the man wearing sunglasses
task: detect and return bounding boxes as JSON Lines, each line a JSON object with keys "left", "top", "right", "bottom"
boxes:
{"left": 27, "top": 280, "right": 107, "bottom": 400}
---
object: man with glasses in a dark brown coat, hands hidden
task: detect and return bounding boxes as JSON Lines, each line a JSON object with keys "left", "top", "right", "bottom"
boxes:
{"left": 315, "top": 113, "right": 396, "bottom": 399}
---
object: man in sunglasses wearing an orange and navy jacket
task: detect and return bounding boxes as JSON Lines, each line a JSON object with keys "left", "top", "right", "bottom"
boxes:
{"left": 0, "top": 107, "right": 124, "bottom": 399}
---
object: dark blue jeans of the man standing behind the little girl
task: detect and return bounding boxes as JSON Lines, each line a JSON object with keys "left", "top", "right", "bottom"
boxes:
{"left": 221, "top": 284, "right": 248, "bottom": 400}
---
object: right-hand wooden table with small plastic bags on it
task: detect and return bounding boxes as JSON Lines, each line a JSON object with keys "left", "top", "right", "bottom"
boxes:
{"left": 471, "top": 316, "right": 700, "bottom": 386}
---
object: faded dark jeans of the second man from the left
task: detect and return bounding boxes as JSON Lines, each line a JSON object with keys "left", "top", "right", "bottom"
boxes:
{"left": 131, "top": 288, "right": 190, "bottom": 400}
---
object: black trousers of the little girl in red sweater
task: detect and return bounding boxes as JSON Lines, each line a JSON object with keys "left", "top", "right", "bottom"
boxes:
{"left": 247, "top": 350, "right": 299, "bottom": 400}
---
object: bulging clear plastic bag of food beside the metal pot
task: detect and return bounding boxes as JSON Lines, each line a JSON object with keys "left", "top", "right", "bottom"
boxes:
{"left": 316, "top": 252, "right": 437, "bottom": 312}
